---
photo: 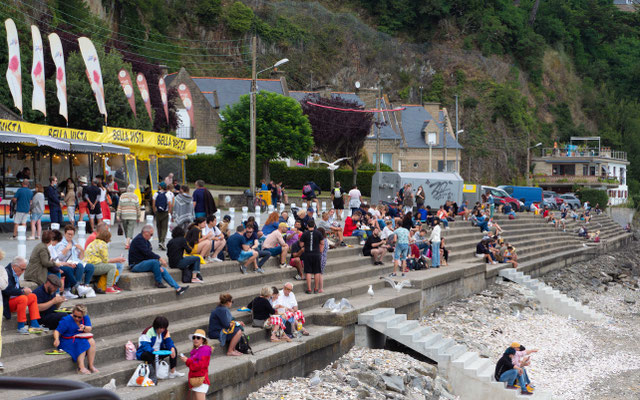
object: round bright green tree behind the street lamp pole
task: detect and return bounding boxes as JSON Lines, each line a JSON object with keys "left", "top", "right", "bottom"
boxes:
{"left": 218, "top": 91, "right": 313, "bottom": 180}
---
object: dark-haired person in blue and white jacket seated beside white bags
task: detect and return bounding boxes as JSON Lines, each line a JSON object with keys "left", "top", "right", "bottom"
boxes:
{"left": 136, "top": 315, "right": 184, "bottom": 379}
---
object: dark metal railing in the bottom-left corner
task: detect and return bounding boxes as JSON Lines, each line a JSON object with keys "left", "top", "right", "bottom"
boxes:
{"left": 0, "top": 376, "right": 120, "bottom": 400}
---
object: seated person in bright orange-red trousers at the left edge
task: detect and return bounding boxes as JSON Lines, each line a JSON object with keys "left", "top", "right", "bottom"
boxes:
{"left": 2, "top": 257, "right": 43, "bottom": 335}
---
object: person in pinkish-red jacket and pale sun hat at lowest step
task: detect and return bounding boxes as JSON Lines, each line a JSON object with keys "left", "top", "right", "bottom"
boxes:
{"left": 180, "top": 329, "right": 213, "bottom": 400}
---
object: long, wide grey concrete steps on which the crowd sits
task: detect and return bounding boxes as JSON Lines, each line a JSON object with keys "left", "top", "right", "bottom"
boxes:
{"left": 2, "top": 208, "right": 629, "bottom": 399}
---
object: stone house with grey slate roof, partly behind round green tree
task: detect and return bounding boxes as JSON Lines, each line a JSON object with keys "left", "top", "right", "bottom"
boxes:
{"left": 165, "top": 68, "right": 289, "bottom": 154}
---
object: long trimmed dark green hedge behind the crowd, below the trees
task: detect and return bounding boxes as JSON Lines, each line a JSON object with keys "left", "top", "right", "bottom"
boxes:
{"left": 185, "top": 154, "right": 375, "bottom": 196}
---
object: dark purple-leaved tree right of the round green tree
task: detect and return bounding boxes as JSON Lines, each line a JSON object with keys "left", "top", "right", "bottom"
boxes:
{"left": 301, "top": 95, "right": 373, "bottom": 187}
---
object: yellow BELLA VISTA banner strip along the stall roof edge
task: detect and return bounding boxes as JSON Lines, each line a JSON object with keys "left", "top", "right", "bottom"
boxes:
{"left": 0, "top": 119, "right": 197, "bottom": 158}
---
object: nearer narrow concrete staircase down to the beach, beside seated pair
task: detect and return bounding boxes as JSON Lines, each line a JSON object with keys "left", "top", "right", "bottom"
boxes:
{"left": 358, "top": 308, "right": 553, "bottom": 400}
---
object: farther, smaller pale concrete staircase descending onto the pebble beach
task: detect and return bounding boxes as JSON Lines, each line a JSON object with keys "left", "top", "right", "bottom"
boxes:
{"left": 499, "top": 268, "right": 606, "bottom": 322}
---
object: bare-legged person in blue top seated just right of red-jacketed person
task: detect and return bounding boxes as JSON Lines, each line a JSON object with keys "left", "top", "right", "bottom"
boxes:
{"left": 209, "top": 293, "right": 244, "bottom": 356}
